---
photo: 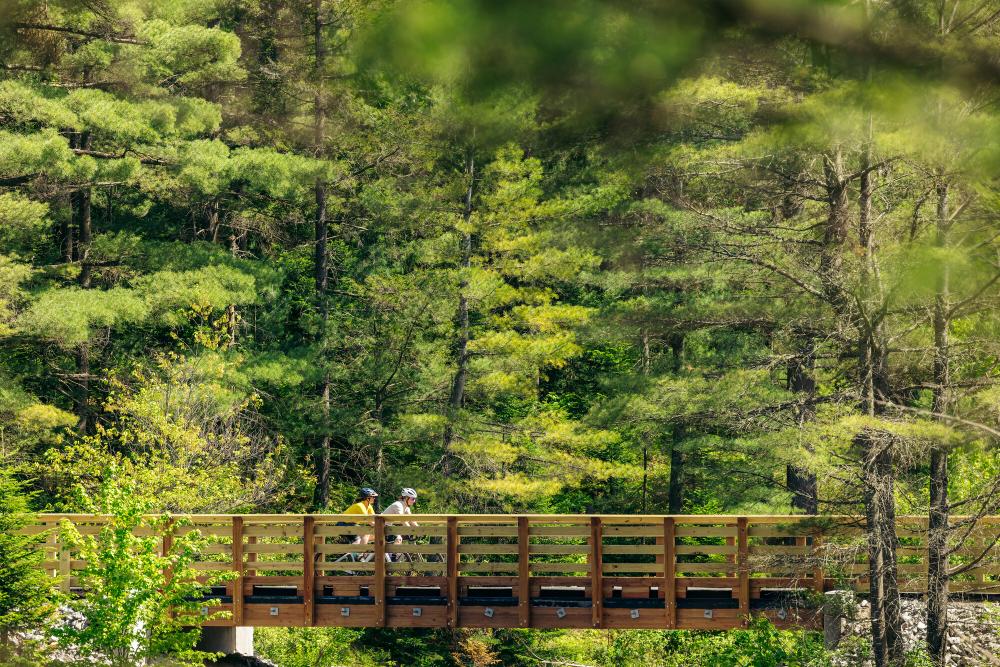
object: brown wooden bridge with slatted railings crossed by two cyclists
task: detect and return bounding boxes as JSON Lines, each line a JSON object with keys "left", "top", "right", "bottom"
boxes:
{"left": 29, "top": 514, "right": 1000, "bottom": 630}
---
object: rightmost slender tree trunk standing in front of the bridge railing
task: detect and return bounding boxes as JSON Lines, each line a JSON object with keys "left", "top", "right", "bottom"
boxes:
{"left": 927, "top": 183, "right": 951, "bottom": 667}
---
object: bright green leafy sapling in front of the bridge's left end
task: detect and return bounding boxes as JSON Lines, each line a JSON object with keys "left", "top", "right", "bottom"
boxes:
{"left": 57, "top": 470, "right": 229, "bottom": 667}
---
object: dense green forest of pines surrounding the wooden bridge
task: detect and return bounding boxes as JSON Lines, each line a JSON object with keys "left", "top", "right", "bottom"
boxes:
{"left": 0, "top": 0, "right": 1000, "bottom": 667}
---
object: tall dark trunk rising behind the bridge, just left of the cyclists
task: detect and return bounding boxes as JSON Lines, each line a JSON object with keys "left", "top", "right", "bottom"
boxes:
{"left": 313, "top": 0, "right": 331, "bottom": 508}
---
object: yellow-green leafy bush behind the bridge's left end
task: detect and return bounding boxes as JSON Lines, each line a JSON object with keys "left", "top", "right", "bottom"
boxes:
{"left": 36, "top": 353, "right": 301, "bottom": 513}
